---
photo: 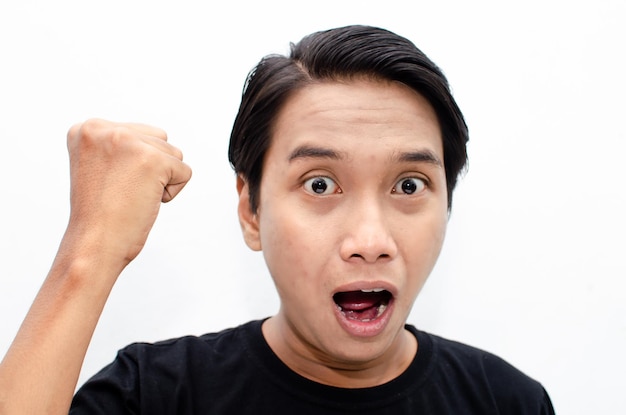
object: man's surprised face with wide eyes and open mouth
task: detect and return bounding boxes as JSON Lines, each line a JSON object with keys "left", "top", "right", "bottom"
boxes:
{"left": 239, "top": 79, "right": 448, "bottom": 376}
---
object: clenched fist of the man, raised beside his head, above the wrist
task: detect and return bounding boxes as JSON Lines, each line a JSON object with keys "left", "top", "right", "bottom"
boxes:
{"left": 66, "top": 119, "right": 191, "bottom": 267}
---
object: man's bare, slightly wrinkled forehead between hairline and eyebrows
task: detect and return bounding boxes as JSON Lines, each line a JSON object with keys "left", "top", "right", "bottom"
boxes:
{"left": 268, "top": 78, "right": 443, "bottom": 159}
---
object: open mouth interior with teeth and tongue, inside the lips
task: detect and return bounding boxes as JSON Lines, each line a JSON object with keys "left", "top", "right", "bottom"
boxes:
{"left": 333, "top": 289, "right": 392, "bottom": 322}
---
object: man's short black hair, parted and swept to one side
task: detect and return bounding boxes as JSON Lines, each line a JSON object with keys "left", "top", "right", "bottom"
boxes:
{"left": 228, "top": 25, "right": 469, "bottom": 213}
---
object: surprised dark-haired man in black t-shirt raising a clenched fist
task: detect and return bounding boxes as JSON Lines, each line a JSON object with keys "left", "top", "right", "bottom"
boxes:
{"left": 0, "top": 26, "right": 553, "bottom": 414}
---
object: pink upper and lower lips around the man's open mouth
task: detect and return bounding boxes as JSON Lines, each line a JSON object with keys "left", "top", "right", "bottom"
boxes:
{"left": 331, "top": 281, "right": 397, "bottom": 338}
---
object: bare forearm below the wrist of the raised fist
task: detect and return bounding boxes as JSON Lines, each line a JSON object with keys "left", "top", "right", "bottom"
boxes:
{"left": 0, "top": 238, "right": 123, "bottom": 415}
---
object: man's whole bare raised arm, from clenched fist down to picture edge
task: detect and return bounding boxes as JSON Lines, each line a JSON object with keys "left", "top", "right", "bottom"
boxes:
{"left": 0, "top": 120, "right": 191, "bottom": 415}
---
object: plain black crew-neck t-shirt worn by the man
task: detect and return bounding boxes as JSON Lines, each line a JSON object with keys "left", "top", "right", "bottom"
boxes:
{"left": 70, "top": 321, "right": 554, "bottom": 415}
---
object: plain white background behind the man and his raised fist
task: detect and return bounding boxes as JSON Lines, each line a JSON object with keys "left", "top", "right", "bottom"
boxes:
{"left": 0, "top": 0, "right": 626, "bottom": 414}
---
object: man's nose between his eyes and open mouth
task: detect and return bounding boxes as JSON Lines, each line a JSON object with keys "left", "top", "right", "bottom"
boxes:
{"left": 341, "top": 200, "right": 398, "bottom": 263}
